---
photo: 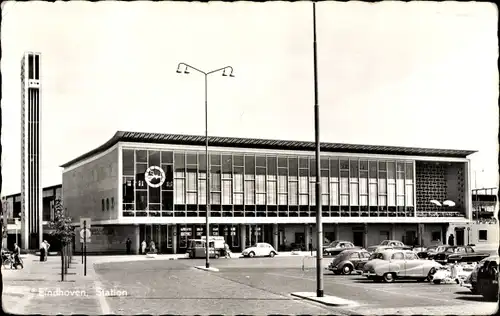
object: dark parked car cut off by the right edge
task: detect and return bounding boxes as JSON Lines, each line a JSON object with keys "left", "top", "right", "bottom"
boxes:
{"left": 477, "top": 256, "right": 500, "bottom": 301}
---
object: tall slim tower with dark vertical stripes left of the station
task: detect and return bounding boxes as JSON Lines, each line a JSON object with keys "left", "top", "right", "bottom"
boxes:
{"left": 21, "top": 52, "right": 43, "bottom": 249}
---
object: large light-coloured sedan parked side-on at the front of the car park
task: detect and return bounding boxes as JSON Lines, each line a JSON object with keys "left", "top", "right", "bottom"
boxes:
{"left": 363, "top": 249, "right": 441, "bottom": 283}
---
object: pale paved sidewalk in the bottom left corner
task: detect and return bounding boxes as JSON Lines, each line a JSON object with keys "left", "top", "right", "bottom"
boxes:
{"left": 2, "top": 255, "right": 102, "bottom": 315}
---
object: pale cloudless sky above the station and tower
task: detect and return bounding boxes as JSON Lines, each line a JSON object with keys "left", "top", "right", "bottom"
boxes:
{"left": 1, "top": 1, "right": 499, "bottom": 195}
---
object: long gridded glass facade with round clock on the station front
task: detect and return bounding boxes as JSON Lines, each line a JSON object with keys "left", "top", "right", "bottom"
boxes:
{"left": 122, "top": 149, "right": 415, "bottom": 217}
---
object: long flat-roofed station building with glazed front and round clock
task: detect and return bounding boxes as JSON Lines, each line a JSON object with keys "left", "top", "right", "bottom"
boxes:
{"left": 56, "top": 131, "right": 474, "bottom": 253}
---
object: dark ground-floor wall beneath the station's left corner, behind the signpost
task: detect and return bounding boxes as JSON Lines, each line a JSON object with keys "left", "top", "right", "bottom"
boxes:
{"left": 75, "top": 225, "right": 139, "bottom": 253}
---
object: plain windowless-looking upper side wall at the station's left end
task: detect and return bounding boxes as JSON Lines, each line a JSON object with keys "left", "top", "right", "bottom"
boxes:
{"left": 63, "top": 149, "right": 120, "bottom": 221}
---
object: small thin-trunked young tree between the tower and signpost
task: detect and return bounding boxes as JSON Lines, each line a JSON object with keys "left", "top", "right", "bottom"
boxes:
{"left": 49, "top": 199, "right": 75, "bottom": 281}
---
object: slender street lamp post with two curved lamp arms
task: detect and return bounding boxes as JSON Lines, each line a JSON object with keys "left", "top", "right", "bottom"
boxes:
{"left": 177, "top": 63, "right": 234, "bottom": 269}
